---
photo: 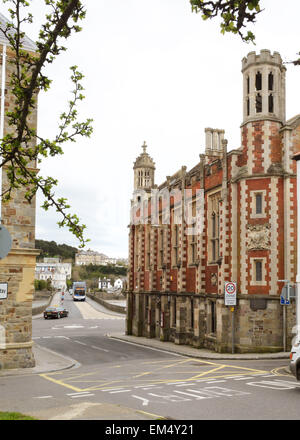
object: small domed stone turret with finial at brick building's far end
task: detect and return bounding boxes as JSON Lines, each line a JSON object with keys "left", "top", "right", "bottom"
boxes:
{"left": 133, "top": 142, "right": 155, "bottom": 191}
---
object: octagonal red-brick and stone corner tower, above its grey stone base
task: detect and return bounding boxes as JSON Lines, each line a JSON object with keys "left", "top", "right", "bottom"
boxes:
{"left": 235, "top": 49, "right": 295, "bottom": 302}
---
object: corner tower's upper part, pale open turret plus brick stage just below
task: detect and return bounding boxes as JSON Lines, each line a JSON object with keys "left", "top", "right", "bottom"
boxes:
{"left": 241, "top": 49, "right": 286, "bottom": 175}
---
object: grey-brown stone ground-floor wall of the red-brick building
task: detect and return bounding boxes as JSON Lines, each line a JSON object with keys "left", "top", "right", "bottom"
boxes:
{"left": 126, "top": 292, "right": 296, "bottom": 353}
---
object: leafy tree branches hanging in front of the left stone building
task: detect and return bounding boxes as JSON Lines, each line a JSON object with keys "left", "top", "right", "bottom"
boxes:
{"left": 0, "top": 0, "right": 92, "bottom": 247}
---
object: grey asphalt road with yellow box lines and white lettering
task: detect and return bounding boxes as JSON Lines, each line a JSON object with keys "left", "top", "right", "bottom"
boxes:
{"left": 0, "top": 295, "right": 300, "bottom": 420}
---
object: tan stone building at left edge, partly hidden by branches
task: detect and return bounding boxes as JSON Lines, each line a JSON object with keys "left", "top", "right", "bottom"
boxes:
{"left": 0, "top": 44, "right": 39, "bottom": 370}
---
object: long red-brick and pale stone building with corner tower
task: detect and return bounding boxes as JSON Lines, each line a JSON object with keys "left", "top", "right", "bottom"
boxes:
{"left": 126, "top": 50, "right": 300, "bottom": 352}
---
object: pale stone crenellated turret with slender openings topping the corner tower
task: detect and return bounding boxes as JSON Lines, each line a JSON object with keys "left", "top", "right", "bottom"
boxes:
{"left": 242, "top": 49, "right": 286, "bottom": 124}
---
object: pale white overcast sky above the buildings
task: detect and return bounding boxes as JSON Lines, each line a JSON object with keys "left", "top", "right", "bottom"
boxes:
{"left": 1, "top": 0, "right": 300, "bottom": 257}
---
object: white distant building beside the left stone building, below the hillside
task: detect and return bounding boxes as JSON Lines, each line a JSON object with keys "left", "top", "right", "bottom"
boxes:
{"left": 35, "top": 258, "right": 72, "bottom": 290}
